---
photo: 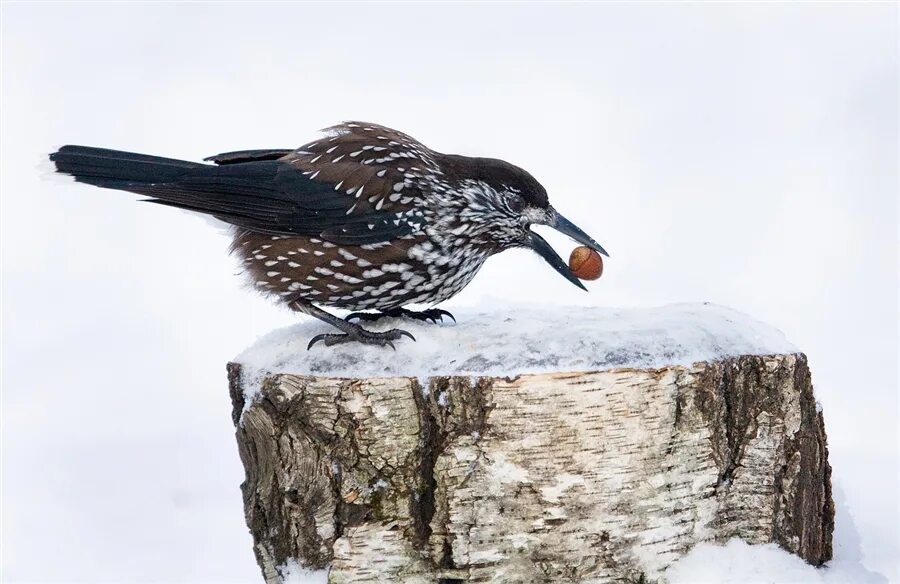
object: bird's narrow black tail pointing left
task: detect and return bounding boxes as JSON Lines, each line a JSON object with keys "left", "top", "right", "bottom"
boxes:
{"left": 50, "top": 146, "right": 208, "bottom": 191}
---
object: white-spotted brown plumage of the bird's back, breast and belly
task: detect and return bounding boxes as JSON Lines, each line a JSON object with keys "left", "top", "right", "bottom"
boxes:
{"left": 241, "top": 122, "right": 552, "bottom": 310}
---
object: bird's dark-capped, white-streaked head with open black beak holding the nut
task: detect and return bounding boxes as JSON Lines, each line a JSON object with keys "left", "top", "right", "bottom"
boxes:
{"left": 440, "top": 156, "right": 609, "bottom": 289}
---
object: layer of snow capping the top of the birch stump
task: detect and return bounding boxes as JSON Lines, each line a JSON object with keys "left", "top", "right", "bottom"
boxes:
{"left": 234, "top": 303, "right": 797, "bottom": 404}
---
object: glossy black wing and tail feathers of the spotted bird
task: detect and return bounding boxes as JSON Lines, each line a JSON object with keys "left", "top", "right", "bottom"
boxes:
{"left": 50, "top": 146, "right": 411, "bottom": 245}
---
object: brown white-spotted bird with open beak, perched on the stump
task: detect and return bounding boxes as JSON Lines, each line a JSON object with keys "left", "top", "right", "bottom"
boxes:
{"left": 49, "top": 121, "right": 608, "bottom": 349}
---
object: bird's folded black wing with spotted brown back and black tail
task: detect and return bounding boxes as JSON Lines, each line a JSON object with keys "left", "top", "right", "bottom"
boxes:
{"left": 50, "top": 122, "right": 440, "bottom": 245}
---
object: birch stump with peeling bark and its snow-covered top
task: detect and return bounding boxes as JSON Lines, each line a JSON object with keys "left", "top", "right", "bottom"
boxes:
{"left": 229, "top": 304, "right": 834, "bottom": 584}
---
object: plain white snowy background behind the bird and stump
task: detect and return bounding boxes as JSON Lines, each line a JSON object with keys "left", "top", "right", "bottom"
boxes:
{"left": 0, "top": 3, "right": 900, "bottom": 582}
